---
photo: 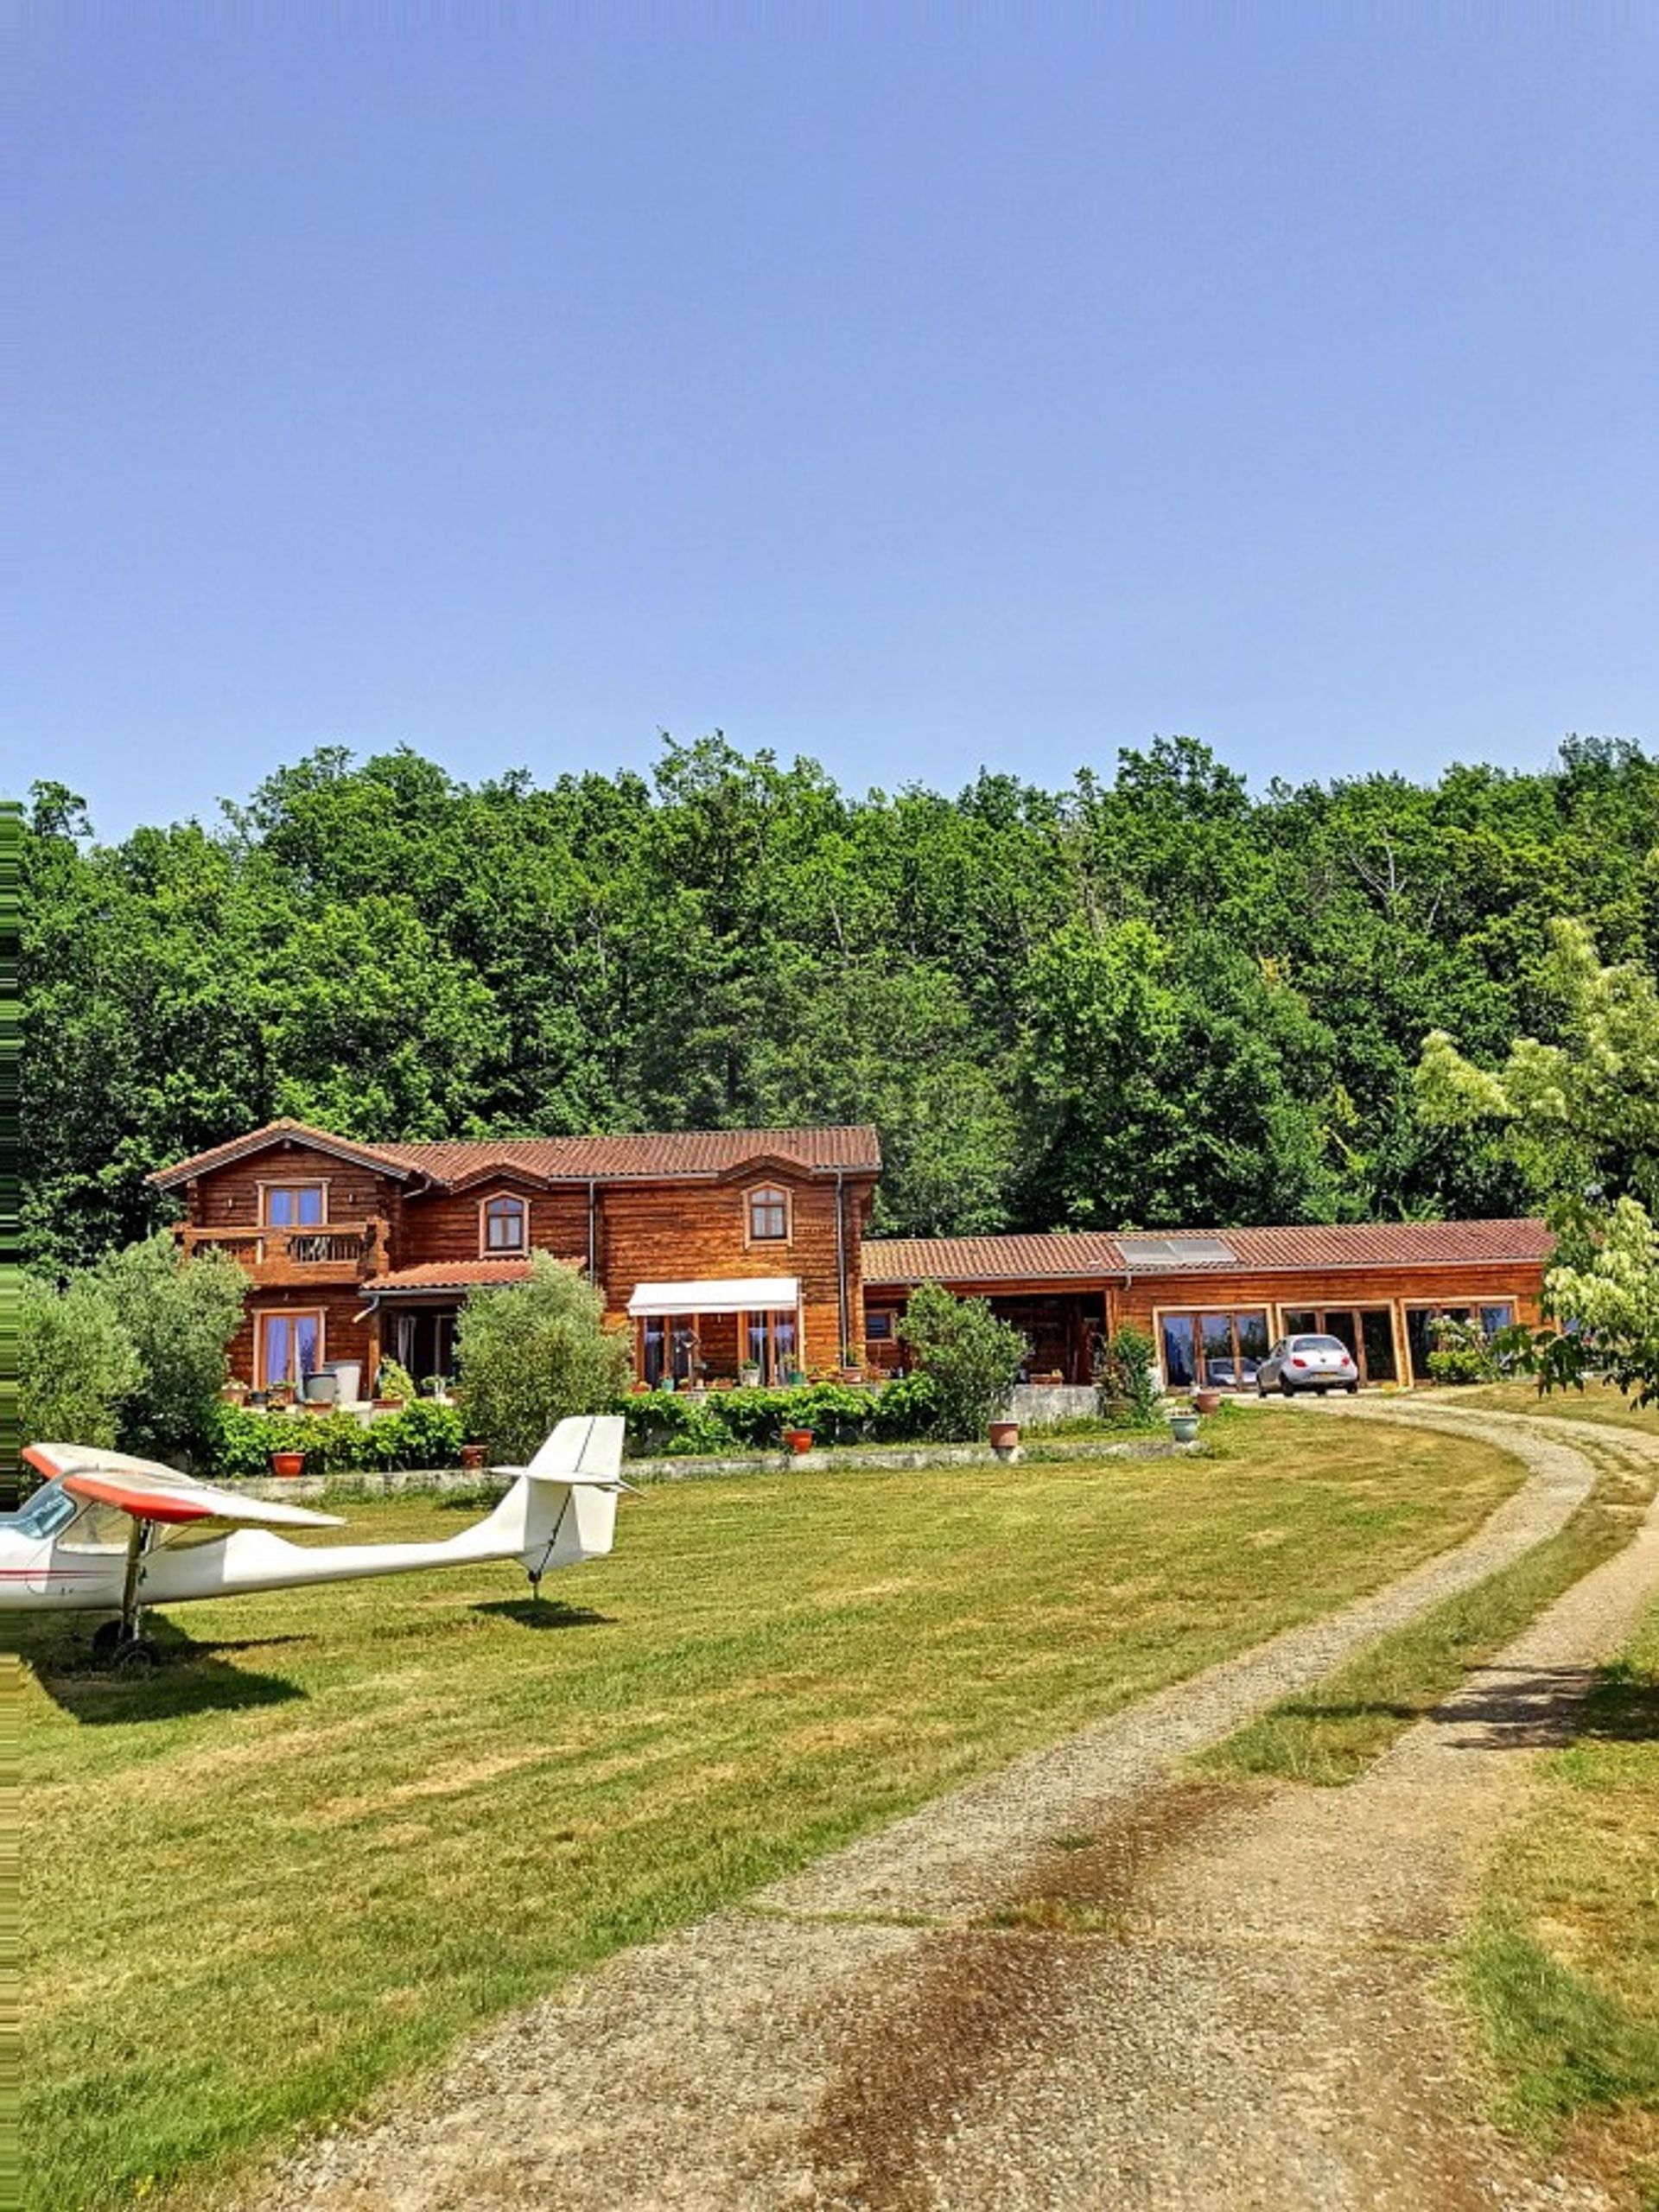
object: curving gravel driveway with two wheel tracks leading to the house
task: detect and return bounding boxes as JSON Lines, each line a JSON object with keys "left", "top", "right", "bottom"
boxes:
{"left": 241, "top": 1405, "right": 1659, "bottom": 2212}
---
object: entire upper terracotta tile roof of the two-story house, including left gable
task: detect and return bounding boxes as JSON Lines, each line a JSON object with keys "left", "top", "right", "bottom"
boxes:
{"left": 150, "top": 1122, "right": 880, "bottom": 1190}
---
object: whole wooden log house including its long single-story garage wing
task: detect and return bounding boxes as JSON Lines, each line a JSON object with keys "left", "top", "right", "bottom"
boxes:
{"left": 150, "top": 1122, "right": 1551, "bottom": 1389}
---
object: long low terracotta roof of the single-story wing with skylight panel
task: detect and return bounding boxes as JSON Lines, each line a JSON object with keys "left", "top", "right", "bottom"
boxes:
{"left": 862, "top": 1221, "right": 1555, "bottom": 1285}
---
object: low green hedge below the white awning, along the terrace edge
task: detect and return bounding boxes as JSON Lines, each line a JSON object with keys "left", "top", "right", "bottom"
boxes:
{"left": 621, "top": 1376, "right": 938, "bottom": 1458}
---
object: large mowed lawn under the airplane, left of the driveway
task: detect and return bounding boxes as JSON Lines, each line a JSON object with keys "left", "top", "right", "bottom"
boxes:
{"left": 22, "top": 1421, "right": 1520, "bottom": 2212}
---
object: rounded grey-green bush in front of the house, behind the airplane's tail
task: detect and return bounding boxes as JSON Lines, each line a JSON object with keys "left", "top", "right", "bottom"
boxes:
{"left": 455, "top": 1252, "right": 628, "bottom": 1462}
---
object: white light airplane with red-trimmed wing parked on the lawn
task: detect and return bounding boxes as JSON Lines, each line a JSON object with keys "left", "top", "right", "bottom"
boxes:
{"left": 0, "top": 1414, "right": 631, "bottom": 1668}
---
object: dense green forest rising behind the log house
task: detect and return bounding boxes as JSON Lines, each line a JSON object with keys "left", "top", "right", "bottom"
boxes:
{"left": 24, "top": 736, "right": 1659, "bottom": 1268}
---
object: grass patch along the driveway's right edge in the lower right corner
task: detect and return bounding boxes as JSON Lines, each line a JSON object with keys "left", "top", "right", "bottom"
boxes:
{"left": 1465, "top": 1606, "right": 1659, "bottom": 2203}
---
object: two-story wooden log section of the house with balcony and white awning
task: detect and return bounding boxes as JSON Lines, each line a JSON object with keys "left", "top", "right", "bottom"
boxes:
{"left": 150, "top": 1122, "right": 880, "bottom": 1389}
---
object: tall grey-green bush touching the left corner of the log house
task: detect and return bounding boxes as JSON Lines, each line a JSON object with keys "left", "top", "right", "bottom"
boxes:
{"left": 93, "top": 1234, "right": 248, "bottom": 1460}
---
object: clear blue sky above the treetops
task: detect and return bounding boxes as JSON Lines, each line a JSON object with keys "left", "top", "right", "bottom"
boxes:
{"left": 0, "top": 4, "right": 1659, "bottom": 834}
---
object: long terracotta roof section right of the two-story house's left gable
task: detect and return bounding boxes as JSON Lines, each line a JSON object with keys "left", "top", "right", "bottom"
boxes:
{"left": 376, "top": 1123, "right": 880, "bottom": 1184}
